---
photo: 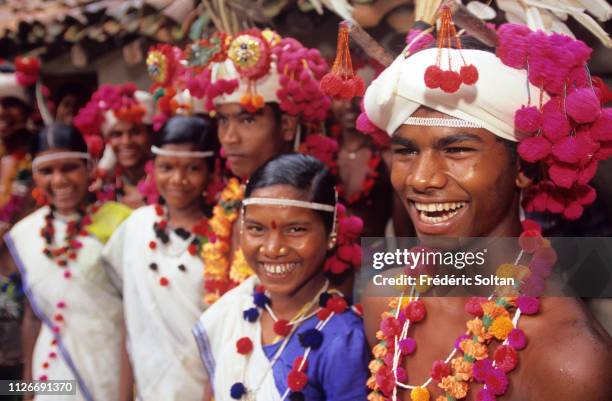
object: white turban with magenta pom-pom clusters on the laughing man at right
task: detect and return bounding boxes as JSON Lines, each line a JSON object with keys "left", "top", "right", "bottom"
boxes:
{"left": 358, "top": 0, "right": 612, "bottom": 220}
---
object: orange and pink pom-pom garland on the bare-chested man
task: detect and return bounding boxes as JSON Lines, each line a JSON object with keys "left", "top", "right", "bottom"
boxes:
{"left": 368, "top": 230, "right": 556, "bottom": 401}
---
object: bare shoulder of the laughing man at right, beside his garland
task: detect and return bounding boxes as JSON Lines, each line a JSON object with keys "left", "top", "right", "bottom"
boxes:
{"left": 523, "top": 298, "right": 612, "bottom": 401}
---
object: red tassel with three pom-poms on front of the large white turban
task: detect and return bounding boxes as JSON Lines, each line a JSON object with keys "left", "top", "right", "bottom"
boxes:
{"left": 423, "top": 5, "right": 478, "bottom": 93}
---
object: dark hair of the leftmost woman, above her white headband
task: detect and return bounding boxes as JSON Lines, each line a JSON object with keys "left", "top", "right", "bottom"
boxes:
{"left": 30, "top": 124, "right": 87, "bottom": 155}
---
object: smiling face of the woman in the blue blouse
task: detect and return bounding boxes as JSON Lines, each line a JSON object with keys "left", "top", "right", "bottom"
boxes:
{"left": 240, "top": 185, "right": 328, "bottom": 295}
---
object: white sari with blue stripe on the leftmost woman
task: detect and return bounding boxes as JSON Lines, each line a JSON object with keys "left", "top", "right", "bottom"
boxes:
{"left": 4, "top": 207, "right": 123, "bottom": 401}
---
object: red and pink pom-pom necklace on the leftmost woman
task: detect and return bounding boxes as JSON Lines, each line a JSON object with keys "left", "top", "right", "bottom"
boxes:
{"left": 38, "top": 203, "right": 99, "bottom": 381}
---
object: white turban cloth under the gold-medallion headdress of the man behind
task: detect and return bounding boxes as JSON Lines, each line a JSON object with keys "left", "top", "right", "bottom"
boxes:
{"left": 211, "top": 59, "right": 280, "bottom": 104}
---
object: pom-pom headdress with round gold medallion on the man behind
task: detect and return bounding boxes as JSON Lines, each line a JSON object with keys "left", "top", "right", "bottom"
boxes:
{"left": 149, "top": 28, "right": 330, "bottom": 122}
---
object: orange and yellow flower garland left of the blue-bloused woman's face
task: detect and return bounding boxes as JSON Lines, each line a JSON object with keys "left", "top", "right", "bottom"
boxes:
{"left": 201, "top": 178, "right": 253, "bottom": 305}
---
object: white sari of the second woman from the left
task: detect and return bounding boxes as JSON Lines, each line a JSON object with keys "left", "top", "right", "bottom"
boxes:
{"left": 103, "top": 206, "right": 207, "bottom": 401}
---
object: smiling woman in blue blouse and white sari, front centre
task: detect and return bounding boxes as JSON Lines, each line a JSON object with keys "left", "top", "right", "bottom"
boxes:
{"left": 194, "top": 154, "right": 369, "bottom": 401}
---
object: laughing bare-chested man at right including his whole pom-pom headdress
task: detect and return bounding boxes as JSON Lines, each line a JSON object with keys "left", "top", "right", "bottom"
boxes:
{"left": 364, "top": 6, "right": 612, "bottom": 401}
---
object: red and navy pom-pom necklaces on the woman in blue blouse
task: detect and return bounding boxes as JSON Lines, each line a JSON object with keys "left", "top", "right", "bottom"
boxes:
{"left": 230, "top": 280, "right": 359, "bottom": 401}
